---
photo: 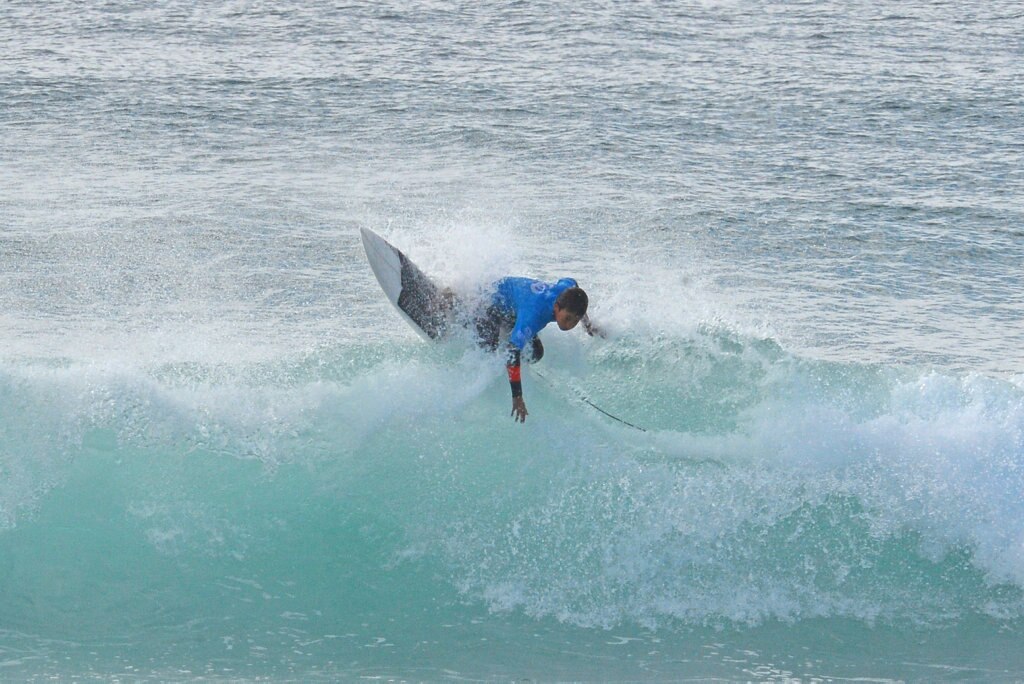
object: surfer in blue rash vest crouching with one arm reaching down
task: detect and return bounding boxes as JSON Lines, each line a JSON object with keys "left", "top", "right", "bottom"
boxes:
{"left": 475, "top": 277, "right": 603, "bottom": 423}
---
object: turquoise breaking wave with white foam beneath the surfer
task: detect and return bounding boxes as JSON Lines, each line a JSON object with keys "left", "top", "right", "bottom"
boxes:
{"left": 0, "top": 325, "right": 1024, "bottom": 627}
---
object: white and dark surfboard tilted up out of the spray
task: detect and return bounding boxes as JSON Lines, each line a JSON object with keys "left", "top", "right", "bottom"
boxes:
{"left": 359, "top": 228, "right": 454, "bottom": 340}
